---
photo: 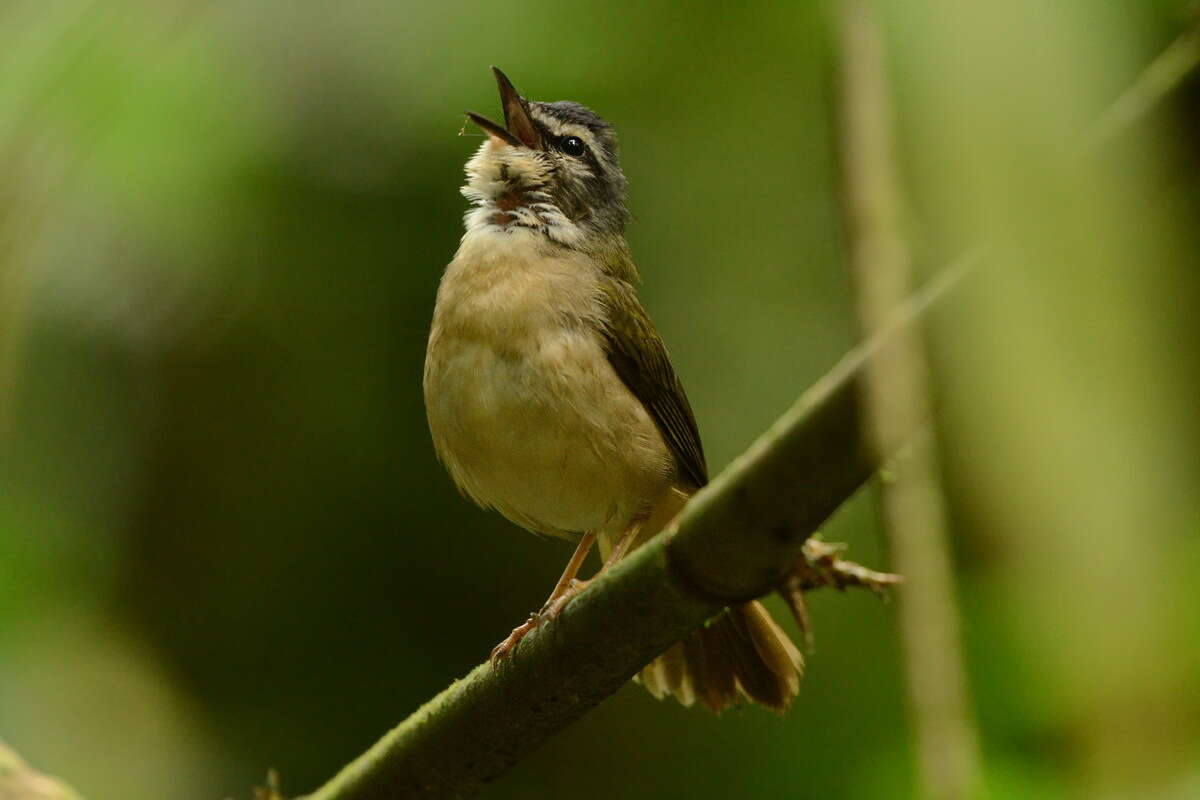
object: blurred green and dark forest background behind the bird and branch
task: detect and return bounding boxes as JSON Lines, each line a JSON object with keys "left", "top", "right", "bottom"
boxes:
{"left": 0, "top": 0, "right": 1200, "bottom": 800}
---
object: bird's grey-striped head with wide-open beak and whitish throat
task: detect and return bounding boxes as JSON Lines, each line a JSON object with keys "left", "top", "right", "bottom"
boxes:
{"left": 462, "top": 67, "right": 629, "bottom": 255}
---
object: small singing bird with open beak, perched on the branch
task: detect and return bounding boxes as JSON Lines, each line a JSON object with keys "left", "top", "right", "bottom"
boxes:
{"left": 424, "top": 67, "right": 803, "bottom": 712}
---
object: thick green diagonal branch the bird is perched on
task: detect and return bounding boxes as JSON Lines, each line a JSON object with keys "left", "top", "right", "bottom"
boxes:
{"left": 308, "top": 270, "right": 962, "bottom": 800}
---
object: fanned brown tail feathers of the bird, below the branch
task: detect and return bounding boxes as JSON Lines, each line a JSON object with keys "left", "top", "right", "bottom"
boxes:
{"left": 637, "top": 601, "right": 804, "bottom": 712}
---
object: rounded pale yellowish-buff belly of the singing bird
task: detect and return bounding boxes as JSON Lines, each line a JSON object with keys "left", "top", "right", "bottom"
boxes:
{"left": 426, "top": 330, "right": 673, "bottom": 535}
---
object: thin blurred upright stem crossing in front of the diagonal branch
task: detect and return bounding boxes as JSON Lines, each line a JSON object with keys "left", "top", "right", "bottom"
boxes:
{"left": 839, "top": 0, "right": 983, "bottom": 800}
